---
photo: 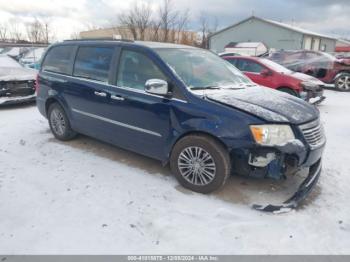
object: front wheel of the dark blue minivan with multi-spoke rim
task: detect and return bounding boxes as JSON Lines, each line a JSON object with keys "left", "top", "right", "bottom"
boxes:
{"left": 170, "top": 135, "right": 231, "bottom": 194}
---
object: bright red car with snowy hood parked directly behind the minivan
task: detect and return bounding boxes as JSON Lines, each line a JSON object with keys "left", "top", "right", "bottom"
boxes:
{"left": 223, "top": 56, "right": 325, "bottom": 103}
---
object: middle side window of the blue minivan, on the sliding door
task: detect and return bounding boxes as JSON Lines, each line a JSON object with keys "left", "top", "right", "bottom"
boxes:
{"left": 73, "top": 47, "right": 114, "bottom": 82}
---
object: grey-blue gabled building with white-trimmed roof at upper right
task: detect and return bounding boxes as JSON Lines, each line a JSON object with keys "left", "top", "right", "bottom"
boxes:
{"left": 209, "top": 16, "right": 337, "bottom": 52}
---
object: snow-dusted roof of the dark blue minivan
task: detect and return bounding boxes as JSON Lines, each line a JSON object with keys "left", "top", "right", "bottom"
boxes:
{"left": 56, "top": 39, "right": 197, "bottom": 49}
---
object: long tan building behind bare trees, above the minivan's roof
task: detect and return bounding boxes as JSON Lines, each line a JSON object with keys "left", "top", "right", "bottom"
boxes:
{"left": 79, "top": 26, "right": 198, "bottom": 45}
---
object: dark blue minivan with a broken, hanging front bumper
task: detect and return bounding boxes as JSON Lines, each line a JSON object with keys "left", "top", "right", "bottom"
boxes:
{"left": 36, "top": 40, "right": 326, "bottom": 210}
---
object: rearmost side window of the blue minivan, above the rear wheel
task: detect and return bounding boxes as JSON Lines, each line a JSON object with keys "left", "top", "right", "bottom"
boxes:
{"left": 42, "top": 45, "right": 75, "bottom": 75}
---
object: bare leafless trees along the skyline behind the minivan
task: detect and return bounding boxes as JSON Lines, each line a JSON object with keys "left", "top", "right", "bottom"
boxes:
{"left": 0, "top": 0, "right": 218, "bottom": 48}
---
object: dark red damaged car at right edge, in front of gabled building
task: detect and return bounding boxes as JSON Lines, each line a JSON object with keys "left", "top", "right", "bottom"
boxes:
{"left": 268, "top": 50, "right": 350, "bottom": 91}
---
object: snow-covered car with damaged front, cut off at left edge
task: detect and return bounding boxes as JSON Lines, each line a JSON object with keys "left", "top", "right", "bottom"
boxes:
{"left": 0, "top": 55, "right": 37, "bottom": 105}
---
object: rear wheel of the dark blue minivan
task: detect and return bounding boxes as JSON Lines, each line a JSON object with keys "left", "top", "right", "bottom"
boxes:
{"left": 47, "top": 103, "right": 77, "bottom": 141}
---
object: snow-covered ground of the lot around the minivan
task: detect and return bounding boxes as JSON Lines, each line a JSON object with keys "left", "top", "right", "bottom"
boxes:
{"left": 0, "top": 91, "right": 350, "bottom": 254}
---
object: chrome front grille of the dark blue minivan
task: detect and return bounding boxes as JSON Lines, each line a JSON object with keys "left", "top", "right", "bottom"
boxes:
{"left": 300, "top": 120, "right": 326, "bottom": 149}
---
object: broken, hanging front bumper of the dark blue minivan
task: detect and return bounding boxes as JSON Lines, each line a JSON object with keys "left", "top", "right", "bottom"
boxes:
{"left": 232, "top": 119, "right": 326, "bottom": 212}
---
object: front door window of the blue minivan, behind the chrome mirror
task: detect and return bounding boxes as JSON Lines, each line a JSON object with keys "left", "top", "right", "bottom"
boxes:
{"left": 117, "top": 50, "right": 167, "bottom": 90}
